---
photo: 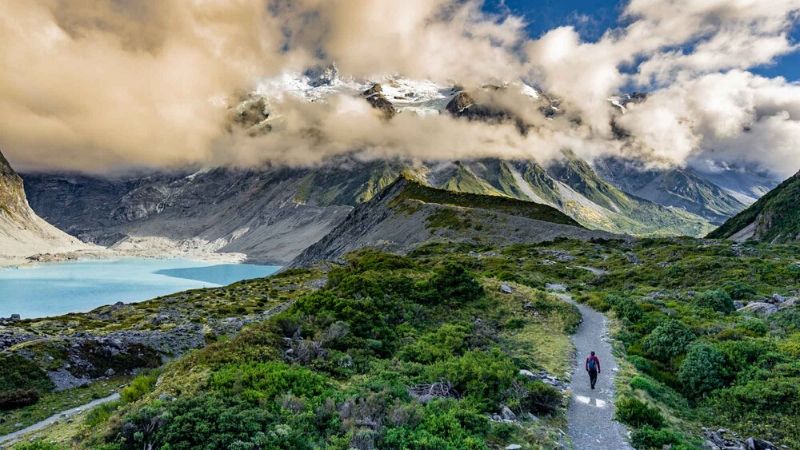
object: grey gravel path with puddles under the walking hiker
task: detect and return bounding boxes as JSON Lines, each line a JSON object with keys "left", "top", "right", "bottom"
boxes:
{"left": 555, "top": 293, "right": 632, "bottom": 450}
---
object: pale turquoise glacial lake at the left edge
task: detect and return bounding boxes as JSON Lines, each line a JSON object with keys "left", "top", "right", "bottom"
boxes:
{"left": 0, "top": 258, "right": 280, "bottom": 318}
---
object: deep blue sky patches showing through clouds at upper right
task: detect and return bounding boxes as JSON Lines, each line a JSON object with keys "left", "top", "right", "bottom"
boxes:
{"left": 486, "top": 0, "right": 800, "bottom": 81}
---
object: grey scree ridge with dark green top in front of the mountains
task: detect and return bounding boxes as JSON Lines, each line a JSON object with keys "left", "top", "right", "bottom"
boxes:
{"left": 291, "top": 176, "right": 615, "bottom": 267}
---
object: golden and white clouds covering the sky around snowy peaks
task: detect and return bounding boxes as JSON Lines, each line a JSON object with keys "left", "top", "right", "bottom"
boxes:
{"left": 0, "top": 0, "right": 800, "bottom": 173}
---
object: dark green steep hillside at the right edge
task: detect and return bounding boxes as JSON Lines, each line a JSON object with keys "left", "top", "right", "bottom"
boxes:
{"left": 708, "top": 172, "right": 800, "bottom": 243}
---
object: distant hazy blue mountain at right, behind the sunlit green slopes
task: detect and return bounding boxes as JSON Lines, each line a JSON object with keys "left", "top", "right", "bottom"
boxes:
{"left": 594, "top": 158, "right": 752, "bottom": 224}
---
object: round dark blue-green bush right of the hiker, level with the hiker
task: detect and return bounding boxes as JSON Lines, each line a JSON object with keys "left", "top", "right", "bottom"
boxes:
{"left": 678, "top": 343, "right": 729, "bottom": 399}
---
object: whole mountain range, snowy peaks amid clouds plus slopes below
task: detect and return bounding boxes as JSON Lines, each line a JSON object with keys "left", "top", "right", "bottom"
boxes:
{"left": 7, "top": 66, "right": 777, "bottom": 264}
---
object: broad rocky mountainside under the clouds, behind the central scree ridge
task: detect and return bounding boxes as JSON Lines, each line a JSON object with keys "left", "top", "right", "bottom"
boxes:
{"left": 25, "top": 156, "right": 711, "bottom": 264}
